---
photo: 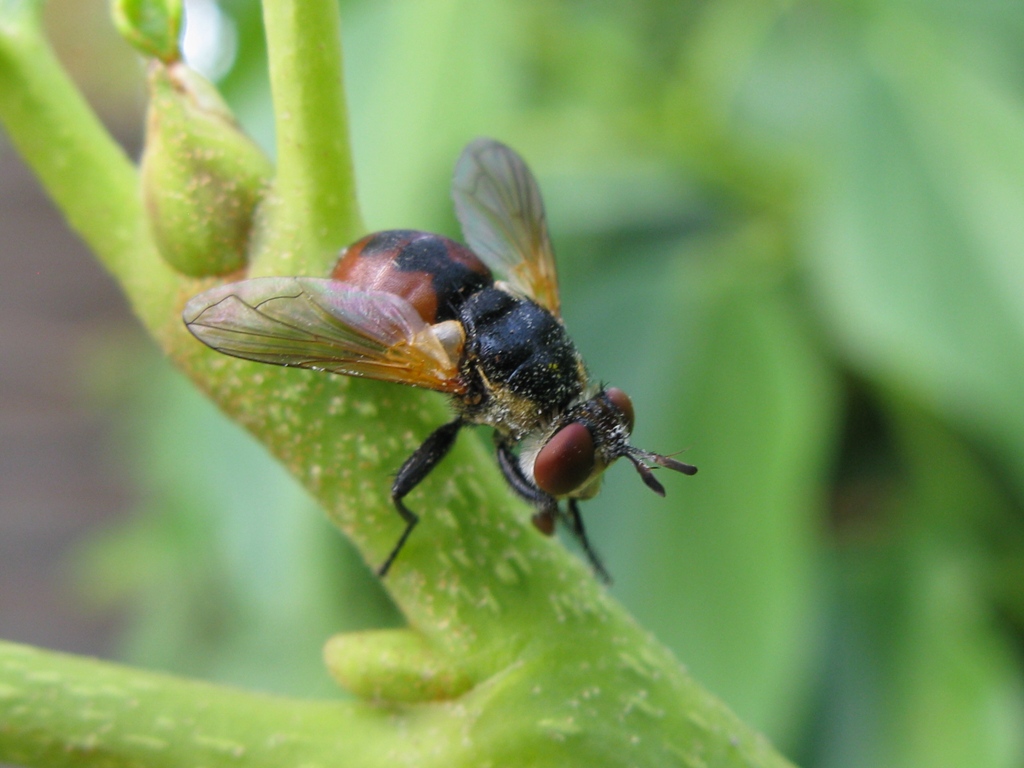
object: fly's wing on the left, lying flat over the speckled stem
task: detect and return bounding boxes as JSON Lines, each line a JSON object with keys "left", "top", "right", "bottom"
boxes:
{"left": 182, "top": 278, "right": 465, "bottom": 393}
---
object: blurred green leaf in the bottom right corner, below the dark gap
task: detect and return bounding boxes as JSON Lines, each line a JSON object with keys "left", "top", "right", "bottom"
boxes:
{"left": 819, "top": 409, "right": 1024, "bottom": 768}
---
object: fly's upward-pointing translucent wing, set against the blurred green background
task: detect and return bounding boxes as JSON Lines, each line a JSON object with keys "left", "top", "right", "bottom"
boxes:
{"left": 452, "top": 138, "right": 559, "bottom": 316}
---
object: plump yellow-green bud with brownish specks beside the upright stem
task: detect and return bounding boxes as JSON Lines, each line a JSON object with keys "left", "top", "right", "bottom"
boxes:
{"left": 142, "top": 61, "right": 273, "bottom": 276}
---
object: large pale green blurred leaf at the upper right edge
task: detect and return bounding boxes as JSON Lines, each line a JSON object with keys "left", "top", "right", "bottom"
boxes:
{"left": 805, "top": 17, "right": 1024, "bottom": 486}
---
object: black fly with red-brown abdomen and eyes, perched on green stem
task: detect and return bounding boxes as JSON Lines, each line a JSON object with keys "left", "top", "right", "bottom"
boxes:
{"left": 184, "top": 139, "right": 696, "bottom": 581}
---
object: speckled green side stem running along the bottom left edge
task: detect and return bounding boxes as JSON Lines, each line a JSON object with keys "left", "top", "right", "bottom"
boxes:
{"left": 0, "top": 642, "right": 389, "bottom": 768}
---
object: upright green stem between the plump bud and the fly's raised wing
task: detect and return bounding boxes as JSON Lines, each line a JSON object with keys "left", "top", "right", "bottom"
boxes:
{"left": 251, "top": 0, "right": 362, "bottom": 275}
